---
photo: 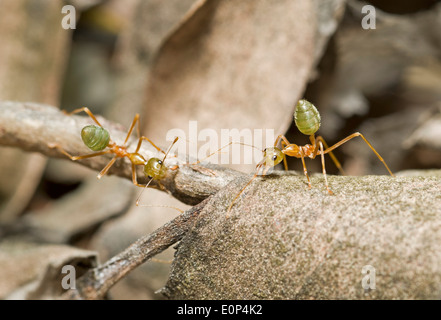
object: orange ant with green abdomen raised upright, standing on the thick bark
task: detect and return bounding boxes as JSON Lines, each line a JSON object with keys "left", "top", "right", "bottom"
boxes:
{"left": 227, "top": 99, "right": 394, "bottom": 212}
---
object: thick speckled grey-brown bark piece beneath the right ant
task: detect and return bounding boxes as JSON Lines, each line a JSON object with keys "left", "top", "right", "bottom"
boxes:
{"left": 163, "top": 170, "right": 441, "bottom": 299}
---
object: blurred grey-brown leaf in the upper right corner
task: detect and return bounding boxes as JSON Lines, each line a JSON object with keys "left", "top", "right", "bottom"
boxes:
{"left": 321, "top": 1, "right": 441, "bottom": 117}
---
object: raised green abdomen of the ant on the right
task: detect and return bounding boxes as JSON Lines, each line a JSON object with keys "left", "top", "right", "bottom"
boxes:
{"left": 294, "top": 100, "right": 320, "bottom": 136}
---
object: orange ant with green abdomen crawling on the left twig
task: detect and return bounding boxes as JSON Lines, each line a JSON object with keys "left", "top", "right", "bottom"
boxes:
{"left": 49, "top": 107, "right": 170, "bottom": 187}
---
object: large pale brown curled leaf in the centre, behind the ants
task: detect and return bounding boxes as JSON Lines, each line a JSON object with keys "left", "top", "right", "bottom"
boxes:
{"left": 144, "top": 0, "right": 316, "bottom": 166}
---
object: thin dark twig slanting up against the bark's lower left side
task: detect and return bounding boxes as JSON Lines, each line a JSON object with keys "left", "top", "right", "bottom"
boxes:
{"left": 62, "top": 198, "right": 209, "bottom": 299}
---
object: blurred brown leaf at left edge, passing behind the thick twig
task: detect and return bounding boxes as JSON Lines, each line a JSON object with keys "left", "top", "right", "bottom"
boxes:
{"left": 0, "top": 0, "right": 70, "bottom": 220}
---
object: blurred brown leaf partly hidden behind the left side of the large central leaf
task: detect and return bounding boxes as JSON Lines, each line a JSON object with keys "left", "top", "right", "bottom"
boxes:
{"left": 110, "top": 0, "right": 196, "bottom": 123}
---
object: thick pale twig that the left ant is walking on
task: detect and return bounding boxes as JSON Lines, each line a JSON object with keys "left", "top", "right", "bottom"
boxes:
{"left": 0, "top": 101, "right": 243, "bottom": 205}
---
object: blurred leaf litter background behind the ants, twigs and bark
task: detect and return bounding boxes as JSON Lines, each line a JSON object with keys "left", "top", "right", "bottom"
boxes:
{"left": 0, "top": 0, "right": 441, "bottom": 299}
